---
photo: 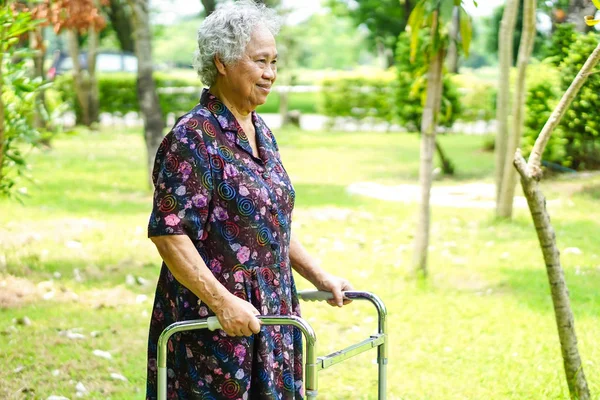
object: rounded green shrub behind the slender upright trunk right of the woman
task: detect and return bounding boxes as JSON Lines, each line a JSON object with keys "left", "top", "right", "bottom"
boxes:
{"left": 395, "top": 31, "right": 462, "bottom": 130}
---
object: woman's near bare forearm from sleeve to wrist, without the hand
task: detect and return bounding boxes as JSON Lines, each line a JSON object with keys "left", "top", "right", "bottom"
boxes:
{"left": 150, "top": 235, "right": 229, "bottom": 312}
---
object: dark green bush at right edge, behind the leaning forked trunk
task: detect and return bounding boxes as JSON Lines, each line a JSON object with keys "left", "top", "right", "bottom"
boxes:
{"left": 559, "top": 33, "right": 600, "bottom": 170}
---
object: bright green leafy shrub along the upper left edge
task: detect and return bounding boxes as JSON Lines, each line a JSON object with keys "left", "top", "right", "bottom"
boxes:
{"left": 0, "top": 5, "right": 43, "bottom": 197}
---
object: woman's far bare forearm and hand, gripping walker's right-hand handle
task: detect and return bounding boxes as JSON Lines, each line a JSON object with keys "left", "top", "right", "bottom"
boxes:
{"left": 290, "top": 235, "right": 352, "bottom": 307}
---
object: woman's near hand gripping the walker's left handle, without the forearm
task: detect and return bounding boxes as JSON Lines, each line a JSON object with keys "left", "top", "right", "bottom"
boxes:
{"left": 215, "top": 294, "right": 260, "bottom": 336}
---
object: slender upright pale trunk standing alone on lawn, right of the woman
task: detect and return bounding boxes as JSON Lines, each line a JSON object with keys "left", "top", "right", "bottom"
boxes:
{"left": 412, "top": 49, "right": 444, "bottom": 277}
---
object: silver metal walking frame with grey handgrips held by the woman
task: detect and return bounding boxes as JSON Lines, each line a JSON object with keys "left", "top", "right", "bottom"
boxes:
{"left": 157, "top": 290, "right": 387, "bottom": 400}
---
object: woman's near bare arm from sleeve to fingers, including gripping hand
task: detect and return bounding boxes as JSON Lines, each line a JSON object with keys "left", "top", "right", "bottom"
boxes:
{"left": 150, "top": 235, "right": 260, "bottom": 336}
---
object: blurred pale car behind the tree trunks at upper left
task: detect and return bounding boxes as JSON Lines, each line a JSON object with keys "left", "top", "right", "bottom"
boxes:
{"left": 47, "top": 51, "right": 137, "bottom": 80}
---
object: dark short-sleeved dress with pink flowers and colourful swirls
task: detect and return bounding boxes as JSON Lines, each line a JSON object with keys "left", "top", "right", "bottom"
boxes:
{"left": 146, "top": 90, "right": 303, "bottom": 400}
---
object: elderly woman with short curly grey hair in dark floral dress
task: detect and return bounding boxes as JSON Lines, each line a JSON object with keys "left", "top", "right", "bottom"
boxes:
{"left": 147, "top": 0, "right": 351, "bottom": 399}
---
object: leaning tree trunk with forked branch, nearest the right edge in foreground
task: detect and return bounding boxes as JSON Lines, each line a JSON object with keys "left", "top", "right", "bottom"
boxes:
{"left": 514, "top": 44, "right": 600, "bottom": 400}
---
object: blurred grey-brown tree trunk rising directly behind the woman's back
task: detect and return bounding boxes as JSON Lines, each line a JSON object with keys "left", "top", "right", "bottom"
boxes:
{"left": 128, "top": 0, "right": 165, "bottom": 187}
